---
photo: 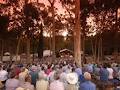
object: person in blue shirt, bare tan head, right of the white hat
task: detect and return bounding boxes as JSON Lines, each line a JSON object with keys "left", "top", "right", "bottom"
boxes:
{"left": 79, "top": 72, "right": 96, "bottom": 90}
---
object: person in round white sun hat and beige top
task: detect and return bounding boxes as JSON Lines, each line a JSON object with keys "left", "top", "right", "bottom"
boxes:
{"left": 66, "top": 68, "right": 78, "bottom": 90}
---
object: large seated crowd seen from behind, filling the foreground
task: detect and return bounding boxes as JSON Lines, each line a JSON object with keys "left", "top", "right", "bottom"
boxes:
{"left": 0, "top": 61, "right": 120, "bottom": 90}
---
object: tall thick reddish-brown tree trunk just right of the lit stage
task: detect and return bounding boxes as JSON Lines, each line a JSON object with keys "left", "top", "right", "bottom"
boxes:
{"left": 74, "top": 0, "right": 82, "bottom": 67}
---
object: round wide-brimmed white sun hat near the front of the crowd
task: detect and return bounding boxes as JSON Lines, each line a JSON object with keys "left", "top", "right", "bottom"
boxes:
{"left": 66, "top": 73, "right": 78, "bottom": 84}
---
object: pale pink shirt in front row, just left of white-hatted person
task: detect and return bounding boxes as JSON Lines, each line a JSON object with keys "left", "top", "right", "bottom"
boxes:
{"left": 50, "top": 80, "right": 65, "bottom": 90}
